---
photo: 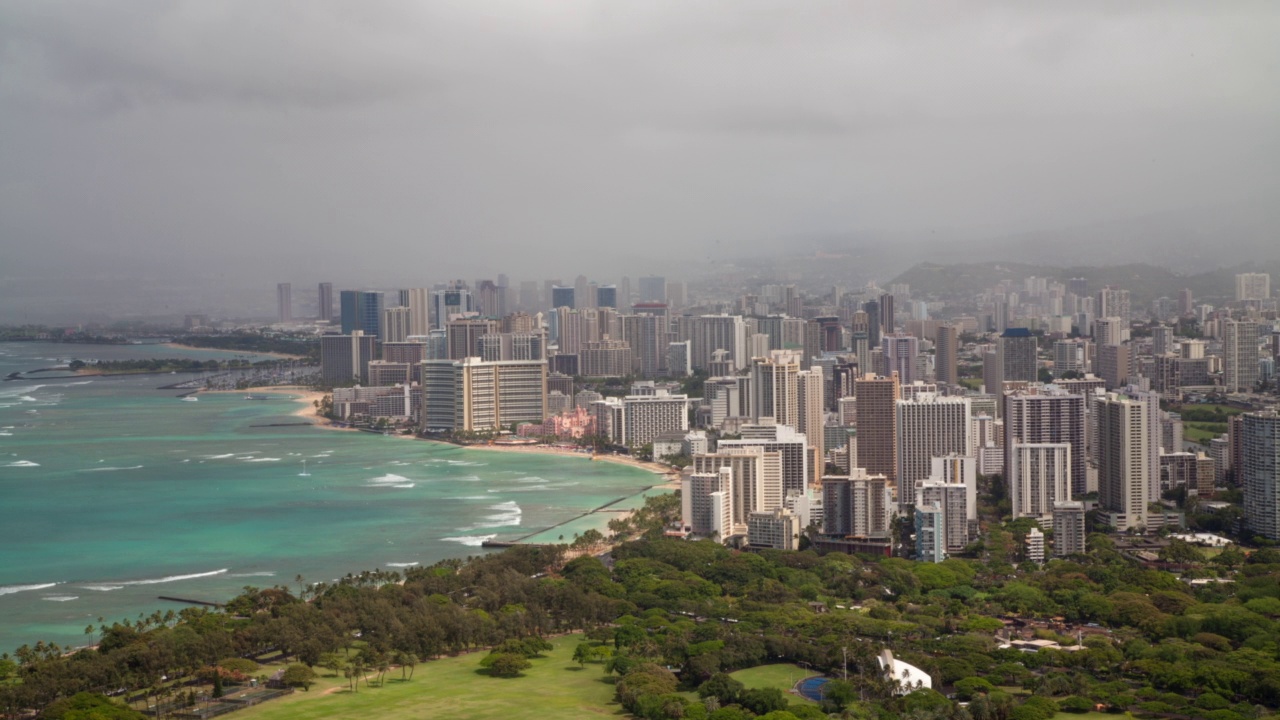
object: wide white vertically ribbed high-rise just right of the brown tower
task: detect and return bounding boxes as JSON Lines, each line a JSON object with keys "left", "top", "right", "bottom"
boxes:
{"left": 896, "top": 392, "right": 973, "bottom": 503}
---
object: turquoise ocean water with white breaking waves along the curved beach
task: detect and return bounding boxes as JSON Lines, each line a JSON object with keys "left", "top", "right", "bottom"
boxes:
{"left": 0, "top": 343, "right": 659, "bottom": 651}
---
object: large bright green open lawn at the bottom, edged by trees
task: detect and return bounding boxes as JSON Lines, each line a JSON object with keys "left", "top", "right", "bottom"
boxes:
{"left": 239, "top": 635, "right": 625, "bottom": 720}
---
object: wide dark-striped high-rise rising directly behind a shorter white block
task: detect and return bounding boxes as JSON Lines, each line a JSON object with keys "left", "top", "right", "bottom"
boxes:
{"left": 1004, "top": 386, "right": 1088, "bottom": 491}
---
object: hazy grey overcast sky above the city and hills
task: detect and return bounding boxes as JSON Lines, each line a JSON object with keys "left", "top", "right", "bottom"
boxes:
{"left": 0, "top": 0, "right": 1280, "bottom": 299}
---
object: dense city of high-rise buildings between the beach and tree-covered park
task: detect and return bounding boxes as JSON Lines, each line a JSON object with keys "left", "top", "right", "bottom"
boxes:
{"left": 285, "top": 266, "right": 1280, "bottom": 550}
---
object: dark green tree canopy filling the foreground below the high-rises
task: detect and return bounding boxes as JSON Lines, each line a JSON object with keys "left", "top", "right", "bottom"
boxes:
{"left": 0, "top": 496, "right": 1280, "bottom": 720}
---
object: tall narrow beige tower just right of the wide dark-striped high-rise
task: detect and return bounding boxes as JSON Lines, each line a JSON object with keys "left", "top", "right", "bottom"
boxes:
{"left": 1097, "top": 393, "right": 1151, "bottom": 532}
